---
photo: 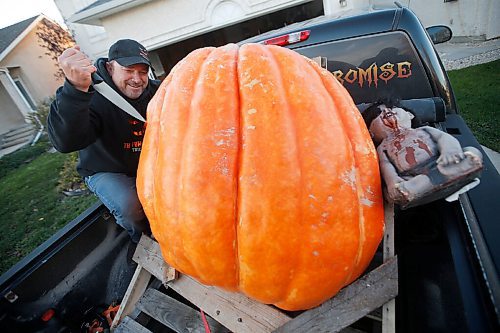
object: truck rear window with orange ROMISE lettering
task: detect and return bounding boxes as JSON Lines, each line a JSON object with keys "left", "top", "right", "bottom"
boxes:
{"left": 294, "top": 31, "right": 433, "bottom": 104}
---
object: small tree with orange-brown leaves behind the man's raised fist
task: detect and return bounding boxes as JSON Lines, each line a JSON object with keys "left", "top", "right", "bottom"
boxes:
{"left": 36, "top": 18, "right": 75, "bottom": 79}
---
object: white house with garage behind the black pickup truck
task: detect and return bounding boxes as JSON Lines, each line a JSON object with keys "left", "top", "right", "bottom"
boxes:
{"left": 54, "top": 0, "right": 500, "bottom": 78}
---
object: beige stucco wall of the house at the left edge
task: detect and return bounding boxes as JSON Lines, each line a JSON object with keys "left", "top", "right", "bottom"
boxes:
{"left": 0, "top": 24, "right": 63, "bottom": 103}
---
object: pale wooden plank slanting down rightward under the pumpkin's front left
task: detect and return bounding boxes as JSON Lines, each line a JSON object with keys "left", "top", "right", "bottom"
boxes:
{"left": 168, "top": 274, "right": 290, "bottom": 333}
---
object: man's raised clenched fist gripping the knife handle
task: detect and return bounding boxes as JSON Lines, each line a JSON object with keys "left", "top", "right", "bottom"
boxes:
{"left": 57, "top": 45, "right": 97, "bottom": 92}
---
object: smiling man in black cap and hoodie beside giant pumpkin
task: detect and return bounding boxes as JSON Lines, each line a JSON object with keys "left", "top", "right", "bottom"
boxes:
{"left": 47, "top": 39, "right": 159, "bottom": 243}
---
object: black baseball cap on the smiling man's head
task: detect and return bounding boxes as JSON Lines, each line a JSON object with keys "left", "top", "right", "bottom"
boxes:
{"left": 108, "top": 39, "right": 151, "bottom": 67}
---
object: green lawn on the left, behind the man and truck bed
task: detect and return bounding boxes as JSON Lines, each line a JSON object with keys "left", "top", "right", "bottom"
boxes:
{"left": 0, "top": 143, "right": 96, "bottom": 274}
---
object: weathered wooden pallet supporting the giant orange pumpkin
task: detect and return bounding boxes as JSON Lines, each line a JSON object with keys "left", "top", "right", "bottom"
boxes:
{"left": 112, "top": 204, "right": 398, "bottom": 333}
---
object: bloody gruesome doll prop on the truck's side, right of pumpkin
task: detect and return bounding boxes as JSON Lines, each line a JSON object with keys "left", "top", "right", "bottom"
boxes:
{"left": 363, "top": 103, "right": 483, "bottom": 209}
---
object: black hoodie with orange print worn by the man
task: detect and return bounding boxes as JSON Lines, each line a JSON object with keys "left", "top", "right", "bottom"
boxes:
{"left": 47, "top": 58, "right": 160, "bottom": 177}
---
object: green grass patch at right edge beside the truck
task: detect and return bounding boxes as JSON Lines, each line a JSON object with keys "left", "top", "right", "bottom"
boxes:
{"left": 448, "top": 60, "right": 500, "bottom": 152}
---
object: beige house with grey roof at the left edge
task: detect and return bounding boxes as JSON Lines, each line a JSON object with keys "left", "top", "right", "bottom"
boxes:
{"left": 0, "top": 14, "right": 71, "bottom": 156}
